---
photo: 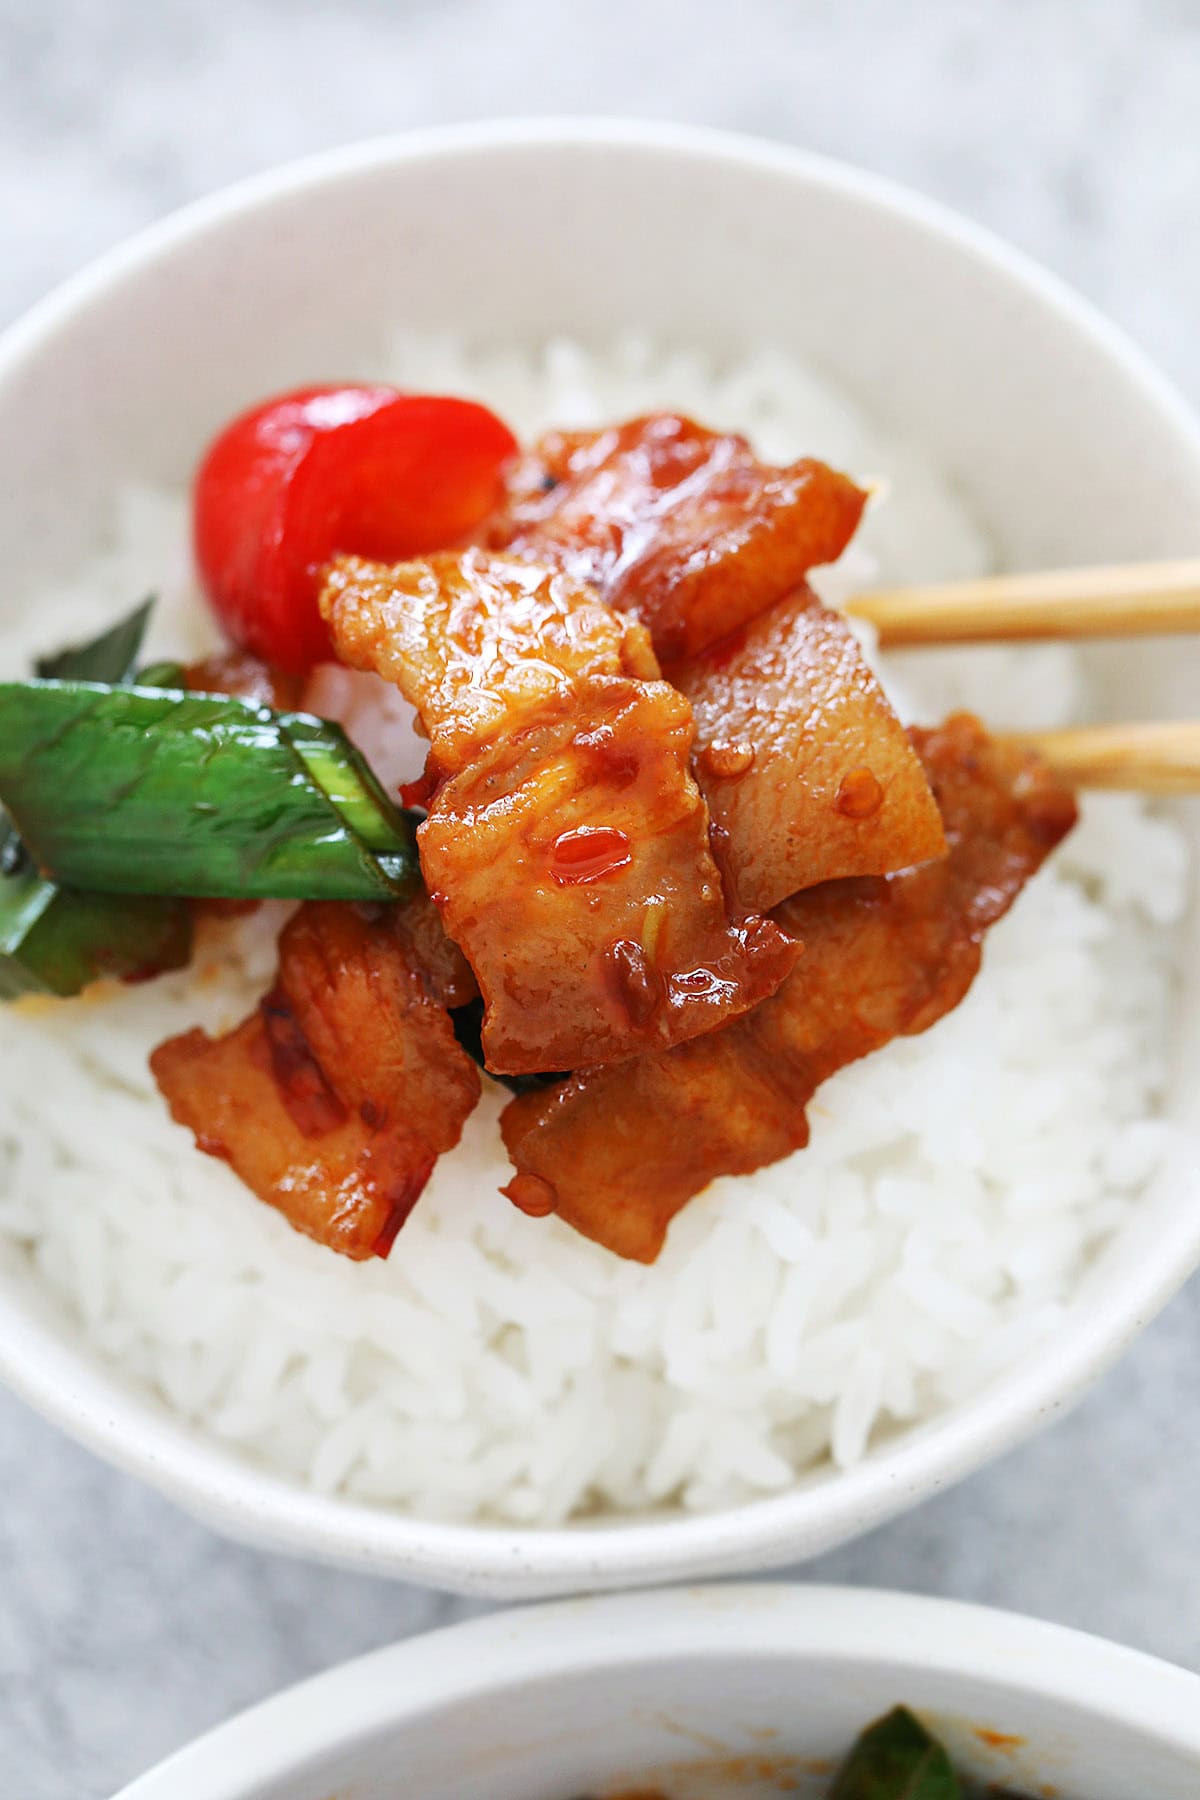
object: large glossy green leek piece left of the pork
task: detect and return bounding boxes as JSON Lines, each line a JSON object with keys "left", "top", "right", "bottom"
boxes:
{"left": 0, "top": 680, "right": 419, "bottom": 900}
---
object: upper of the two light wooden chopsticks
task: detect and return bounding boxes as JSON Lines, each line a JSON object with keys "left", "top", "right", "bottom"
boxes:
{"left": 846, "top": 558, "right": 1200, "bottom": 648}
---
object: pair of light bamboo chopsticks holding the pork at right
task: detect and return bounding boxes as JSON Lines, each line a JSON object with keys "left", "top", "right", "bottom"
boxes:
{"left": 846, "top": 558, "right": 1200, "bottom": 794}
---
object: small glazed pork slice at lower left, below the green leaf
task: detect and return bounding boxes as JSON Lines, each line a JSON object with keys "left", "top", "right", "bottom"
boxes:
{"left": 151, "top": 902, "right": 480, "bottom": 1260}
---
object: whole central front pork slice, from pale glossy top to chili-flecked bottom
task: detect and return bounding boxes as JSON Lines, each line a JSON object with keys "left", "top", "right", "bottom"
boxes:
{"left": 322, "top": 551, "right": 797, "bottom": 1075}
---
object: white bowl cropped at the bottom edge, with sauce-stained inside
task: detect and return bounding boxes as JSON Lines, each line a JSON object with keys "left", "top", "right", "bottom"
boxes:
{"left": 117, "top": 1586, "right": 1200, "bottom": 1800}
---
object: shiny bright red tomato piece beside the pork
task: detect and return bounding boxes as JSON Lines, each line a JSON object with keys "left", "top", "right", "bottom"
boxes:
{"left": 193, "top": 387, "right": 516, "bottom": 675}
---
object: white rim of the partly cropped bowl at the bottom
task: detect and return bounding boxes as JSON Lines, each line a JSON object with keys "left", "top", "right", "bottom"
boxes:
{"left": 115, "top": 1582, "right": 1200, "bottom": 1800}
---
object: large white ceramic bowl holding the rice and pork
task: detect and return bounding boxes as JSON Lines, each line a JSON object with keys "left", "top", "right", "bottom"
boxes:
{"left": 0, "top": 122, "right": 1200, "bottom": 1595}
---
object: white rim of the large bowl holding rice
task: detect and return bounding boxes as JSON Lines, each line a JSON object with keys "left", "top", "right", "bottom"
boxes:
{"left": 0, "top": 117, "right": 1200, "bottom": 1597}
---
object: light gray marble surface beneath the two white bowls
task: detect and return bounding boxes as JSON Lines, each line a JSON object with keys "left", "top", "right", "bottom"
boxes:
{"left": 0, "top": 0, "right": 1200, "bottom": 1800}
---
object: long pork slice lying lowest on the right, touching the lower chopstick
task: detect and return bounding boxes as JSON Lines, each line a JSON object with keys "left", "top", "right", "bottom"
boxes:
{"left": 502, "top": 715, "right": 1076, "bottom": 1262}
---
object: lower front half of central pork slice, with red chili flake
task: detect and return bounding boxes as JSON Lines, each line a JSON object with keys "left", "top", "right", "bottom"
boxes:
{"left": 417, "top": 679, "right": 797, "bottom": 1075}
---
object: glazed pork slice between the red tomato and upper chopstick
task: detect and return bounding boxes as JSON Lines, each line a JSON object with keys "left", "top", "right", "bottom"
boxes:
{"left": 489, "top": 414, "right": 946, "bottom": 914}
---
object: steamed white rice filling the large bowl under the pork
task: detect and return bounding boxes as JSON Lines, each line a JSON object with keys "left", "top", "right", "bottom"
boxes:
{"left": 0, "top": 340, "right": 1187, "bottom": 1525}
